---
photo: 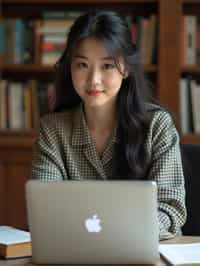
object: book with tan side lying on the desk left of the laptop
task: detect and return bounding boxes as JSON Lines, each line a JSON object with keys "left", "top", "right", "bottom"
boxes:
{"left": 0, "top": 225, "right": 32, "bottom": 259}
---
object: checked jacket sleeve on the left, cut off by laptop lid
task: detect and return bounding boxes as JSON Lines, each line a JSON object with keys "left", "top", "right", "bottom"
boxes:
{"left": 31, "top": 116, "right": 67, "bottom": 181}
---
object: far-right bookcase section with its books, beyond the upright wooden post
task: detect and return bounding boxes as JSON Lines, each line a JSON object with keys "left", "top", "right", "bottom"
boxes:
{"left": 181, "top": 0, "right": 200, "bottom": 143}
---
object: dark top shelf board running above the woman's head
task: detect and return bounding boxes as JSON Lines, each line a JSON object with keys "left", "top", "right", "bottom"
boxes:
{"left": 1, "top": 0, "right": 159, "bottom": 19}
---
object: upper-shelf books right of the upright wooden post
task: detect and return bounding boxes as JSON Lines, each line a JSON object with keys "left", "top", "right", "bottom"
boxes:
{"left": 181, "top": 15, "right": 200, "bottom": 65}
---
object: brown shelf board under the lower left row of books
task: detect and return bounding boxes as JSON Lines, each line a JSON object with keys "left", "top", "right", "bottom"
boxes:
{"left": 0, "top": 130, "right": 37, "bottom": 149}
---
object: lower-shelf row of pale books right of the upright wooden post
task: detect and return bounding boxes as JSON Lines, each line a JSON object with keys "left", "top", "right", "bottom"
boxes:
{"left": 179, "top": 77, "right": 200, "bottom": 134}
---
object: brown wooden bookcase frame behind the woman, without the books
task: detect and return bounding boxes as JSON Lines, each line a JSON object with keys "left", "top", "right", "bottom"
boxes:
{"left": 0, "top": 0, "right": 200, "bottom": 229}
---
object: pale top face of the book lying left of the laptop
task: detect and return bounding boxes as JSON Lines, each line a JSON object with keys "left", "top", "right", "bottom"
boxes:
{"left": 0, "top": 226, "right": 31, "bottom": 245}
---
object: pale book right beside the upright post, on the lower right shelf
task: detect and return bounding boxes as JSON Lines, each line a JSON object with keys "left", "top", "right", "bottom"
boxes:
{"left": 179, "top": 78, "right": 190, "bottom": 134}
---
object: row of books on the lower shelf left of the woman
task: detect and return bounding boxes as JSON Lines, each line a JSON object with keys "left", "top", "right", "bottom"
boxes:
{"left": 0, "top": 80, "right": 55, "bottom": 130}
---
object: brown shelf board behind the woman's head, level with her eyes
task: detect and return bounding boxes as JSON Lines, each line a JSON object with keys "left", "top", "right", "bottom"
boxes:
{"left": 0, "top": 64, "right": 157, "bottom": 74}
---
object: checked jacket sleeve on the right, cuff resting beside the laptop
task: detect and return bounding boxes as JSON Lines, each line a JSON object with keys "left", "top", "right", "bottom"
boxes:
{"left": 149, "top": 111, "right": 186, "bottom": 239}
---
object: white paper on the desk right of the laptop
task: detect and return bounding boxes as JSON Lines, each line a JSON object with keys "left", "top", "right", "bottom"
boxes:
{"left": 159, "top": 243, "right": 200, "bottom": 265}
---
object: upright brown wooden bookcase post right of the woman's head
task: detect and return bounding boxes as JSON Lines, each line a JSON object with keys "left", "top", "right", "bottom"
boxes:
{"left": 158, "top": 0, "right": 182, "bottom": 116}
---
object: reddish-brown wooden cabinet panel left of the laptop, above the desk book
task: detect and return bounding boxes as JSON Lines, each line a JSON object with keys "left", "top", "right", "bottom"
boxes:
{"left": 0, "top": 145, "right": 32, "bottom": 229}
